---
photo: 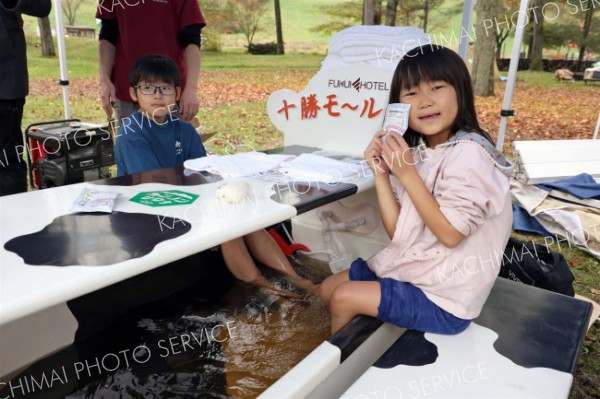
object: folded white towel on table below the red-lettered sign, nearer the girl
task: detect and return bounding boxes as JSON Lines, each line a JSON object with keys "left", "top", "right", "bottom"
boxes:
{"left": 279, "top": 154, "right": 357, "bottom": 183}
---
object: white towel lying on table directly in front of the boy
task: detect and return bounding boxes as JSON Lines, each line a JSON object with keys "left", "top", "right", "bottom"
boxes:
{"left": 183, "top": 152, "right": 293, "bottom": 177}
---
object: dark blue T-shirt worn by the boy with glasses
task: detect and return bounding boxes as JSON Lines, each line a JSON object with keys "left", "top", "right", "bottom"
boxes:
{"left": 115, "top": 111, "right": 206, "bottom": 176}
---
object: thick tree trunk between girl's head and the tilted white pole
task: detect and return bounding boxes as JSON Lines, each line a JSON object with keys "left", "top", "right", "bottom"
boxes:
{"left": 471, "top": 0, "right": 498, "bottom": 97}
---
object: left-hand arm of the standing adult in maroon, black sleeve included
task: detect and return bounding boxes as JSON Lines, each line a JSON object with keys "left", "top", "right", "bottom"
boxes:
{"left": 98, "top": 19, "right": 119, "bottom": 118}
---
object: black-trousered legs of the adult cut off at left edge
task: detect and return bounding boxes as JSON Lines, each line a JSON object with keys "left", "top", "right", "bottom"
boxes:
{"left": 0, "top": 98, "right": 27, "bottom": 196}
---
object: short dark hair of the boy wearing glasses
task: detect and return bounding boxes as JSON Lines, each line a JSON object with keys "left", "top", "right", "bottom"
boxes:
{"left": 129, "top": 54, "right": 181, "bottom": 87}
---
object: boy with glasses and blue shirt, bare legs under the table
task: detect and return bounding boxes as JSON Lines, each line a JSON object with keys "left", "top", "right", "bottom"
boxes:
{"left": 115, "top": 54, "right": 316, "bottom": 297}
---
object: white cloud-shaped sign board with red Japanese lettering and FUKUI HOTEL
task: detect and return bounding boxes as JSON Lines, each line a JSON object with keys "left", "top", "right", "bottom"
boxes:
{"left": 267, "top": 63, "right": 393, "bottom": 155}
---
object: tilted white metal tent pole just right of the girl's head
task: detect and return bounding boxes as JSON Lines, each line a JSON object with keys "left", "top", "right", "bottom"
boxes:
{"left": 496, "top": 0, "right": 529, "bottom": 151}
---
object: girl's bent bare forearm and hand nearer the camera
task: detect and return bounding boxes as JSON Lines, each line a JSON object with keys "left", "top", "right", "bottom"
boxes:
{"left": 382, "top": 134, "right": 465, "bottom": 248}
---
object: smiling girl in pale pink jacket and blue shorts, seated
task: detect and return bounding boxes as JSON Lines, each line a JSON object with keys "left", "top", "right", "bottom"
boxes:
{"left": 321, "top": 45, "right": 512, "bottom": 334}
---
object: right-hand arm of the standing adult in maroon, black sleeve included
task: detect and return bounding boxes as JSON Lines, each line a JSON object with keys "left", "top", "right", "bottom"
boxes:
{"left": 178, "top": 24, "right": 202, "bottom": 121}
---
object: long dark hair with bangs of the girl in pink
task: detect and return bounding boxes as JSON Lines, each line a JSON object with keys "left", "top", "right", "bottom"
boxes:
{"left": 390, "top": 44, "right": 493, "bottom": 147}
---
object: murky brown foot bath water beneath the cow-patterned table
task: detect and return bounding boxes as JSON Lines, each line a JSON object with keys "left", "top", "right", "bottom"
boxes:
{"left": 2, "top": 258, "right": 330, "bottom": 398}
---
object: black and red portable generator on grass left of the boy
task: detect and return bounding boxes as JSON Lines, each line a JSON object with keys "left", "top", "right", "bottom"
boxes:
{"left": 25, "top": 119, "right": 115, "bottom": 189}
